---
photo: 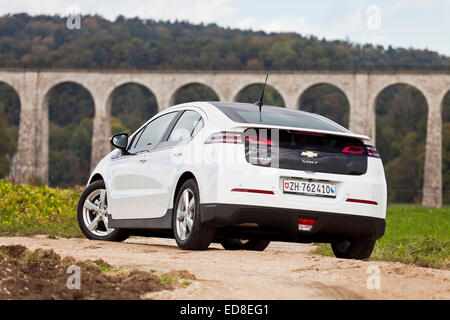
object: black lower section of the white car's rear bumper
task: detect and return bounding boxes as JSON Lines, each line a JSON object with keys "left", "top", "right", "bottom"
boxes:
{"left": 201, "top": 203, "right": 386, "bottom": 243}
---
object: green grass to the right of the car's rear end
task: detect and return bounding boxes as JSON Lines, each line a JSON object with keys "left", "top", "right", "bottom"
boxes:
{"left": 317, "top": 205, "right": 450, "bottom": 269}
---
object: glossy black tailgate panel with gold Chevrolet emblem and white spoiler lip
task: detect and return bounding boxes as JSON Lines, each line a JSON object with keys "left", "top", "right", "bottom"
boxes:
{"left": 241, "top": 124, "right": 370, "bottom": 175}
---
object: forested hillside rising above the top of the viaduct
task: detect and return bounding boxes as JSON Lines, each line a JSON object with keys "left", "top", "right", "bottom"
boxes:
{"left": 0, "top": 14, "right": 450, "bottom": 70}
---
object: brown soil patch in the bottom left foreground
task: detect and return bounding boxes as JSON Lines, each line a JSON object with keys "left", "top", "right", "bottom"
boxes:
{"left": 0, "top": 245, "right": 175, "bottom": 299}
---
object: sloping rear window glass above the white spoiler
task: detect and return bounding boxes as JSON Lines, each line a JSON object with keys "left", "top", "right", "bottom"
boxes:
{"left": 214, "top": 103, "right": 349, "bottom": 132}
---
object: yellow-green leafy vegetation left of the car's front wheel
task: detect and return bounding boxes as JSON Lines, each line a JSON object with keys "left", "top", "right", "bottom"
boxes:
{"left": 0, "top": 181, "right": 82, "bottom": 238}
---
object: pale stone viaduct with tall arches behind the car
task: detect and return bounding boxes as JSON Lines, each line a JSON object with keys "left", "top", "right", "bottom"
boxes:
{"left": 0, "top": 69, "right": 450, "bottom": 207}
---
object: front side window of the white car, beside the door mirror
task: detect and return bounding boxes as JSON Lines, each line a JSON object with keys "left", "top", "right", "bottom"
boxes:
{"left": 132, "top": 112, "right": 177, "bottom": 152}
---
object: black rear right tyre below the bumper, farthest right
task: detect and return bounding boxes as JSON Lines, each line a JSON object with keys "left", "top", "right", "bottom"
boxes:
{"left": 331, "top": 240, "right": 376, "bottom": 260}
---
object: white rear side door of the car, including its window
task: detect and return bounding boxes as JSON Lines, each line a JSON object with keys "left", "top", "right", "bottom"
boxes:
{"left": 145, "top": 110, "right": 203, "bottom": 218}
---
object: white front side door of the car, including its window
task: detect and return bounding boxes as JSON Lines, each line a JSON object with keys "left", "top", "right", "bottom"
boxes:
{"left": 108, "top": 111, "right": 179, "bottom": 219}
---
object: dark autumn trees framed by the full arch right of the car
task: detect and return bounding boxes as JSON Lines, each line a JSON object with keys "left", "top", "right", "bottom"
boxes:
{"left": 376, "top": 85, "right": 427, "bottom": 203}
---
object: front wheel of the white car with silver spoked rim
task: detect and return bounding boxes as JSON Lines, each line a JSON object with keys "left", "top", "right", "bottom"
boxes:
{"left": 77, "top": 181, "right": 129, "bottom": 241}
